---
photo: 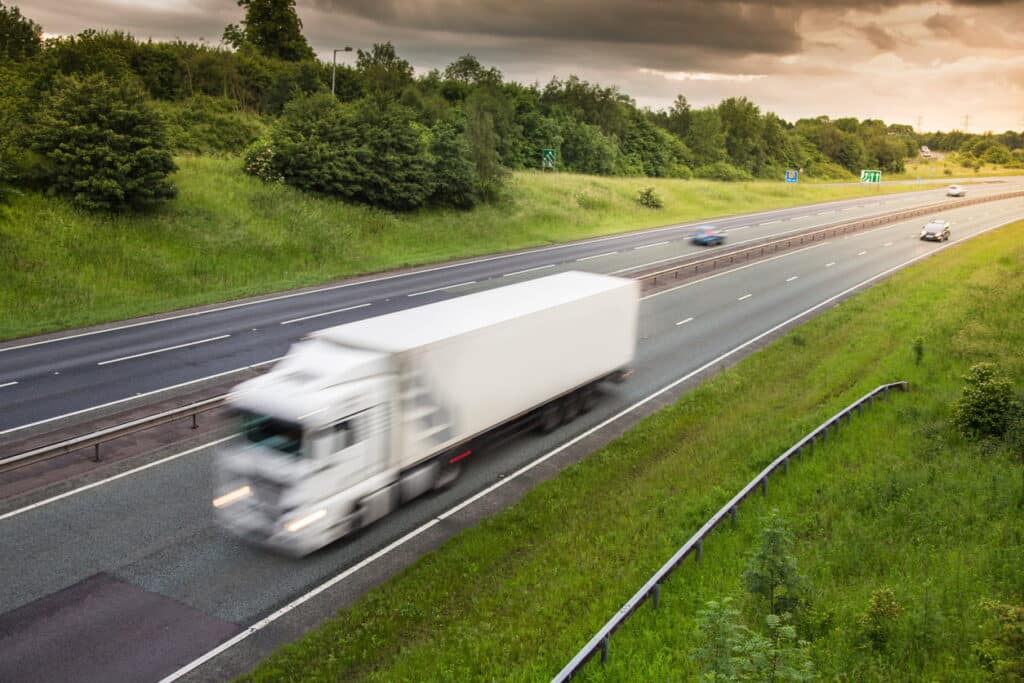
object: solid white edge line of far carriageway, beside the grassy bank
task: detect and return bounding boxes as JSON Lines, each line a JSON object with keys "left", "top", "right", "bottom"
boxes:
{"left": 0, "top": 189, "right": 962, "bottom": 358}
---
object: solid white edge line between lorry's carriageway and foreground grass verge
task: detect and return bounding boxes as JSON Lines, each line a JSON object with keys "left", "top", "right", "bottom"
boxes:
{"left": 160, "top": 215, "right": 998, "bottom": 683}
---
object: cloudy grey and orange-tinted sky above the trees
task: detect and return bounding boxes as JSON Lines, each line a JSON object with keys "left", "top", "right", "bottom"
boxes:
{"left": 16, "top": 0, "right": 1024, "bottom": 132}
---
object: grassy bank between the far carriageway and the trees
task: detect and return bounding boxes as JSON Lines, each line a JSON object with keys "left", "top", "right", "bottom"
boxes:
{"left": 0, "top": 157, "right": 942, "bottom": 339}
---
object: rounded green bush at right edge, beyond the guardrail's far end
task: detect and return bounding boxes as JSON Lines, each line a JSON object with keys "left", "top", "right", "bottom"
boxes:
{"left": 953, "top": 362, "right": 1020, "bottom": 437}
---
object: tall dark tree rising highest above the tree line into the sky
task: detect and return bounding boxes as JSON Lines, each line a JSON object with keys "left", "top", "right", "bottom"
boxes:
{"left": 223, "top": 0, "right": 315, "bottom": 61}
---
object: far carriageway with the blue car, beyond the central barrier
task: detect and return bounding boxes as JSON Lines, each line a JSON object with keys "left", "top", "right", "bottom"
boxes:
{"left": 0, "top": 177, "right": 1024, "bottom": 436}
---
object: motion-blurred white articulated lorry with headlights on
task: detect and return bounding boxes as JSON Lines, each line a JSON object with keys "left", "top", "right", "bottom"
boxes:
{"left": 213, "top": 271, "right": 640, "bottom": 555}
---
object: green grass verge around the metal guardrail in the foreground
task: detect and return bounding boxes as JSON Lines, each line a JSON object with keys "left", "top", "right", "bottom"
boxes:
{"left": 239, "top": 222, "right": 1024, "bottom": 681}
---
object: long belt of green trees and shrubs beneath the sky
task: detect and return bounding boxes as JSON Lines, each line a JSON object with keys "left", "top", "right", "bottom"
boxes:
{"left": 0, "top": 0, "right": 1024, "bottom": 210}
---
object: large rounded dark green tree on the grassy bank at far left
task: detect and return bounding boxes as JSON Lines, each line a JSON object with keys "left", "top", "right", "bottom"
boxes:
{"left": 31, "top": 74, "right": 177, "bottom": 210}
